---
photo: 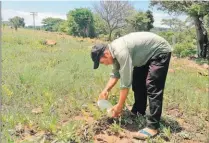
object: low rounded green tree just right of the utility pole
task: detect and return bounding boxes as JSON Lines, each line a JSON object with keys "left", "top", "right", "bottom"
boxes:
{"left": 42, "top": 17, "right": 65, "bottom": 32}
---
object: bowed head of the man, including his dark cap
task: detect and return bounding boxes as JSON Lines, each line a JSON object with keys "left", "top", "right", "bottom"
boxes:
{"left": 91, "top": 44, "right": 113, "bottom": 69}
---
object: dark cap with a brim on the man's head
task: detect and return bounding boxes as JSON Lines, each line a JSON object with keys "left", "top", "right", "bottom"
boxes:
{"left": 91, "top": 44, "right": 107, "bottom": 69}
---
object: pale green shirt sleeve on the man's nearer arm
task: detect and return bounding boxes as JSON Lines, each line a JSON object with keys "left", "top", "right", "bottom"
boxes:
{"left": 118, "top": 49, "right": 133, "bottom": 89}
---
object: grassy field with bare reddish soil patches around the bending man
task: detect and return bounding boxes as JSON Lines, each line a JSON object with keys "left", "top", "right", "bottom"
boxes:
{"left": 1, "top": 27, "right": 209, "bottom": 143}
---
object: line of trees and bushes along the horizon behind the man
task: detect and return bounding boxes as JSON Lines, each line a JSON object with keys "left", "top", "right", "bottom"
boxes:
{"left": 3, "top": 1, "right": 209, "bottom": 58}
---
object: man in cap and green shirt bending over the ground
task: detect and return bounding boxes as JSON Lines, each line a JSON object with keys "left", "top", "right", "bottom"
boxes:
{"left": 91, "top": 32, "right": 172, "bottom": 139}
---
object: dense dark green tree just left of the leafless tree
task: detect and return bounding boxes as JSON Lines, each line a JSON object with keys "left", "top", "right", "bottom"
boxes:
{"left": 67, "top": 8, "right": 95, "bottom": 38}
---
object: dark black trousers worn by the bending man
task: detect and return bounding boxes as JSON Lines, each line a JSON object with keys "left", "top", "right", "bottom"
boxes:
{"left": 132, "top": 53, "right": 171, "bottom": 129}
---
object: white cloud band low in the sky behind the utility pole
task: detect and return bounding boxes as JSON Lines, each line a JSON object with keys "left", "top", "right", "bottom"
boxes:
{"left": 2, "top": 9, "right": 67, "bottom": 26}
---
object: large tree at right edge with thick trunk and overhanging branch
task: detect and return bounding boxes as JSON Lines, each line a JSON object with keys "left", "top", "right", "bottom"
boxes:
{"left": 151, "top": 0, "right": 209, "bottom": 58}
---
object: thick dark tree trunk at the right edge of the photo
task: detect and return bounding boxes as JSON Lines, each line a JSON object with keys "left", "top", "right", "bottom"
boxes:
{"left": 194, "top": 16, "right": 209, "bottom": 58}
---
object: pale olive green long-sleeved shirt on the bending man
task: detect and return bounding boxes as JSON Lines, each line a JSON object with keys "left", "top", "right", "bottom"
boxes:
{"left": 108, "top": 32, "right": 172, "bottom": 88}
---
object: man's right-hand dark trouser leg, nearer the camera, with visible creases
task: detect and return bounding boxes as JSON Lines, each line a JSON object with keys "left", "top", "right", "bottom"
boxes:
{"left": 146, "top": 53, "right": 171, "bottom": 129}
